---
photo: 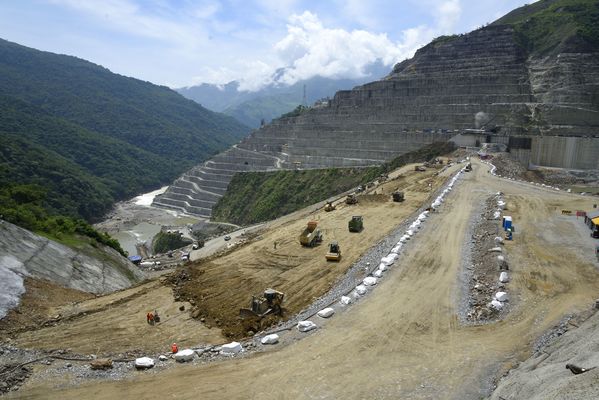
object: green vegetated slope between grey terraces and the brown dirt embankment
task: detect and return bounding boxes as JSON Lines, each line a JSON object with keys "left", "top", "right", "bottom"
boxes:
{"left": 212, "top": 143, "right": 454, "bottom": 225}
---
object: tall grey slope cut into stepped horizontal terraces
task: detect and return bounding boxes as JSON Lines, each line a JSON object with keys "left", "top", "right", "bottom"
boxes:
{"left": 153, "top": 25, "right": 599, "bottom": 218}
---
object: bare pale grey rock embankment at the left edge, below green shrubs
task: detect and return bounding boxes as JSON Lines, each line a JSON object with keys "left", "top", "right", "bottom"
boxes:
{"left": 0, "top": 221, "right": 143, "bottom": 318}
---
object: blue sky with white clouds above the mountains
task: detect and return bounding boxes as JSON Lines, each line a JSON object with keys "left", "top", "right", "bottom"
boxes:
{"left": 0, "top": 0, "right": 532, "bottom": 90}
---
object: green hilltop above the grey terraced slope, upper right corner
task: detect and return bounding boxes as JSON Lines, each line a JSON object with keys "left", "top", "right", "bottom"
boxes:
{"left": 493, "top": 0, "right": 599, "bottom": 56}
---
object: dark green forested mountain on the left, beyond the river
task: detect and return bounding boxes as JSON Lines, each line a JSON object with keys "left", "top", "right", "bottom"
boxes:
{"left": 0, "top": 40, "right": 249, "bottom": 248}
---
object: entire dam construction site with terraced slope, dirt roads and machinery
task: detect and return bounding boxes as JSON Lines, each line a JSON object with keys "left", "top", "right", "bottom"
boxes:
{"left": 0, "top": 0, "right": 599, "bottom": 400}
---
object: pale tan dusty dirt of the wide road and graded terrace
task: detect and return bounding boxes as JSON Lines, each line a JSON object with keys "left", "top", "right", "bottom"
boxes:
{"left": 8, "top": 158, "right": 599, "bottom": 399}
